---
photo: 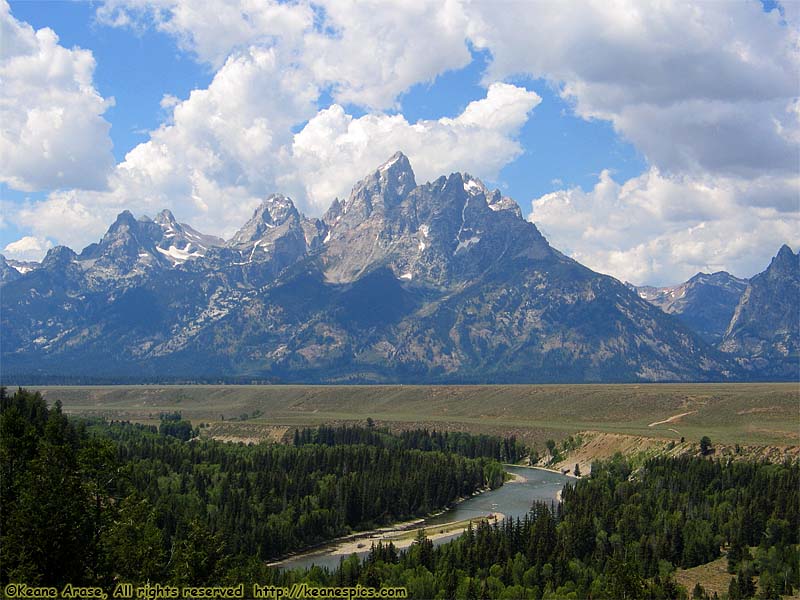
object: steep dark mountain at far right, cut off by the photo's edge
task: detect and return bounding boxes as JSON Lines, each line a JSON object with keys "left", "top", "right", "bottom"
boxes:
{"left": 720, "top": 244, "right": 800, "bottom": 381}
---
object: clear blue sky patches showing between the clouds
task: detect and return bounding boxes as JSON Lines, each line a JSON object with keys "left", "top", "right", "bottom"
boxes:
{"left": 0, "top": 0, "right": 645, "bottom": 202}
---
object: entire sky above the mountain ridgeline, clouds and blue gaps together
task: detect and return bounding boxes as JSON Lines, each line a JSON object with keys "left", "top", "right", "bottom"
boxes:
{"left": 0, "top": 0, "right": 800, "bottom": 283}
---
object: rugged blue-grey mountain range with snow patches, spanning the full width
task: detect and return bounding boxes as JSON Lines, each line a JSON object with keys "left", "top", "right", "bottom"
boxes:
{"left": 0, "top": 153, "right": 800, "bottom": 383}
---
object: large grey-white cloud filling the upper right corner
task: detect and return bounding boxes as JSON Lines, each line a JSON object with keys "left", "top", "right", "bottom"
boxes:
{"left": 471, "top": 0, "right": 800, "bottom": 177}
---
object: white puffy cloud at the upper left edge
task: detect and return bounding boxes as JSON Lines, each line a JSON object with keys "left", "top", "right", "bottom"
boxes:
{"left": 0, "top": 0, "right": 114, "bottom": 191}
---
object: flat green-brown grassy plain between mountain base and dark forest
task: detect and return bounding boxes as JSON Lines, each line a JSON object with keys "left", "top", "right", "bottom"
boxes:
{"left": 26, "top": 383, "right": 800, "bottom": 446}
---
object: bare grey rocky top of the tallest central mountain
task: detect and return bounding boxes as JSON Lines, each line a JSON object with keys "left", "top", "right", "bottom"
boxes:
{"left": 322, "top": 154, "right": 551, "bottom": 287}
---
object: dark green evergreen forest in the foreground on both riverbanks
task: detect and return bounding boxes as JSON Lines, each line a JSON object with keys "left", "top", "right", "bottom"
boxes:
{"left": 0, "top": 388, "right": 800, "bottom": 600}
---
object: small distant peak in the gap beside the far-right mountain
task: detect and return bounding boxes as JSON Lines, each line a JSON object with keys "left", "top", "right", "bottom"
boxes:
{"left": 631, "top": 271, "right": 747, "bottom": 345}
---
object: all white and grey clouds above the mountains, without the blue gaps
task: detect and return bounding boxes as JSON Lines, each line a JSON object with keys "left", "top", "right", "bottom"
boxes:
{"left": 0, "top": 0, "right": 800, "bottom": 283}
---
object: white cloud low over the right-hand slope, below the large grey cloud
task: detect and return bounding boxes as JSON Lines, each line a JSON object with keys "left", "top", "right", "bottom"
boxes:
{"left": 529, "top": 168, "right": 800, "bottom": 285}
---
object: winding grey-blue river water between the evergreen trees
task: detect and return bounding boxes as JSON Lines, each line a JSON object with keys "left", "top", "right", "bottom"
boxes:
{"left": 279, "top": 466, "right": 574, "bottom": 569}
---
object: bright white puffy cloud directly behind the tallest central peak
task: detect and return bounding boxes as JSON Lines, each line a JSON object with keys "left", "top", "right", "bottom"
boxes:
{"left": 279, "top": 83, "right": 541, "bottom": 213}
